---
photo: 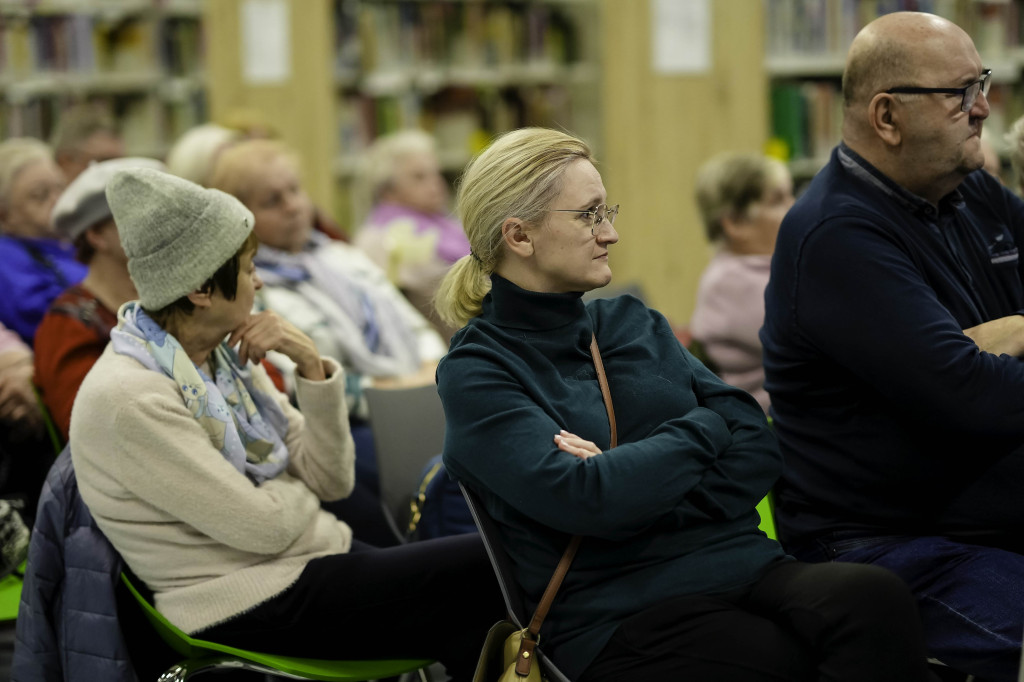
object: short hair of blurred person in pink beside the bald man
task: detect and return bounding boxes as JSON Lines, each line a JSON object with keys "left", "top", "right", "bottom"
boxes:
{"left": 696, "top": 153, "right": 787, "bottom": 242}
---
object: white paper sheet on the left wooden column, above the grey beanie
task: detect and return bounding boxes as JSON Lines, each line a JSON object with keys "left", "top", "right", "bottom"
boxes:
{"left": 241, "top": 0, "right": 292, "bottom": 85}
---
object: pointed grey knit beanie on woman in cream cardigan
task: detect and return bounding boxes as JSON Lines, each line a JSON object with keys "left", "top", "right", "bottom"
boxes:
{"left": 106, "top": 168, "right": 255, "bottom": 310}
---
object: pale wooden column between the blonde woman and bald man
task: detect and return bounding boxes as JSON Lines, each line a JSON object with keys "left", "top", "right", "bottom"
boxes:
{"left": 599, "top": 0, "right": 768, "bottom": 324}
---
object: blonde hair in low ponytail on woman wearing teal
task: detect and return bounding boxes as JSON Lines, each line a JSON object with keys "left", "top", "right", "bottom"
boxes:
{"left": 434, "top": 128, "right": 594, "bottom": 328}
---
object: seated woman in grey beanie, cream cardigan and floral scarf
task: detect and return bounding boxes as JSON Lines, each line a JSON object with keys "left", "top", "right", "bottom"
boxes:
{"left": 71, "top": 168, "right": 502, "bottom": 680}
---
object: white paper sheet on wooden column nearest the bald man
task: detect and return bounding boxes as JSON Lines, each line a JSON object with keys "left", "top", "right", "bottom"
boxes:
{"left": 650, "top": 0, "right": 711, "bottom": 75}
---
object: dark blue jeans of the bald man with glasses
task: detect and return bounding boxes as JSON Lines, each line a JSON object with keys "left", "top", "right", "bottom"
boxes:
{"left": 794, "top": 534, "right": 1024, "bottom": 682}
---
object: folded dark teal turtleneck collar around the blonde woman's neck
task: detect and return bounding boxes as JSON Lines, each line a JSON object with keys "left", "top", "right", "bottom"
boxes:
{"left": 481, "top": 274, "right": 586, "bottom": 331}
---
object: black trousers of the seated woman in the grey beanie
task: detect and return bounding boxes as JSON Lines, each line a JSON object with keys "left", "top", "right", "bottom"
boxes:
{"left": 197, "top": 534, "right": 505, "bottom": 681}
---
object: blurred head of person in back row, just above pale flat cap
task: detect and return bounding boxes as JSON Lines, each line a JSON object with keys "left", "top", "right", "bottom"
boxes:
{"left": 50, "top": 103, "right": 125, "bottom": 182}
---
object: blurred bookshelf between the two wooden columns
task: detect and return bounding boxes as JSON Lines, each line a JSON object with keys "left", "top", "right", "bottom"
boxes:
{"left": 334, "top": 0, "right": 600, "bottom": 220}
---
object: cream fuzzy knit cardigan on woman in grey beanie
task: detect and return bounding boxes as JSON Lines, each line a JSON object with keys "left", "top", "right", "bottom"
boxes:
{"left": 70, "top": 345, "right": 355, "bottom": 633}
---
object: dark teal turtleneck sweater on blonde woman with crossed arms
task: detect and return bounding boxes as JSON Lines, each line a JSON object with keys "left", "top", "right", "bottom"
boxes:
{"left": 437, "top": 275, "right": 784, "bottom": 678}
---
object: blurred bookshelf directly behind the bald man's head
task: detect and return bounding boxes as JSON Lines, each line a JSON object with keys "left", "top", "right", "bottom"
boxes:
{"left": 764, "top": 0, "right": 1024, "bottom": 179}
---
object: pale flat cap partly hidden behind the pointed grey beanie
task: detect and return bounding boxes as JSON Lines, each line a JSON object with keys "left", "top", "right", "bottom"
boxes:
{"left": 50, "top": 157, "right": 165, "bottom": 242}
